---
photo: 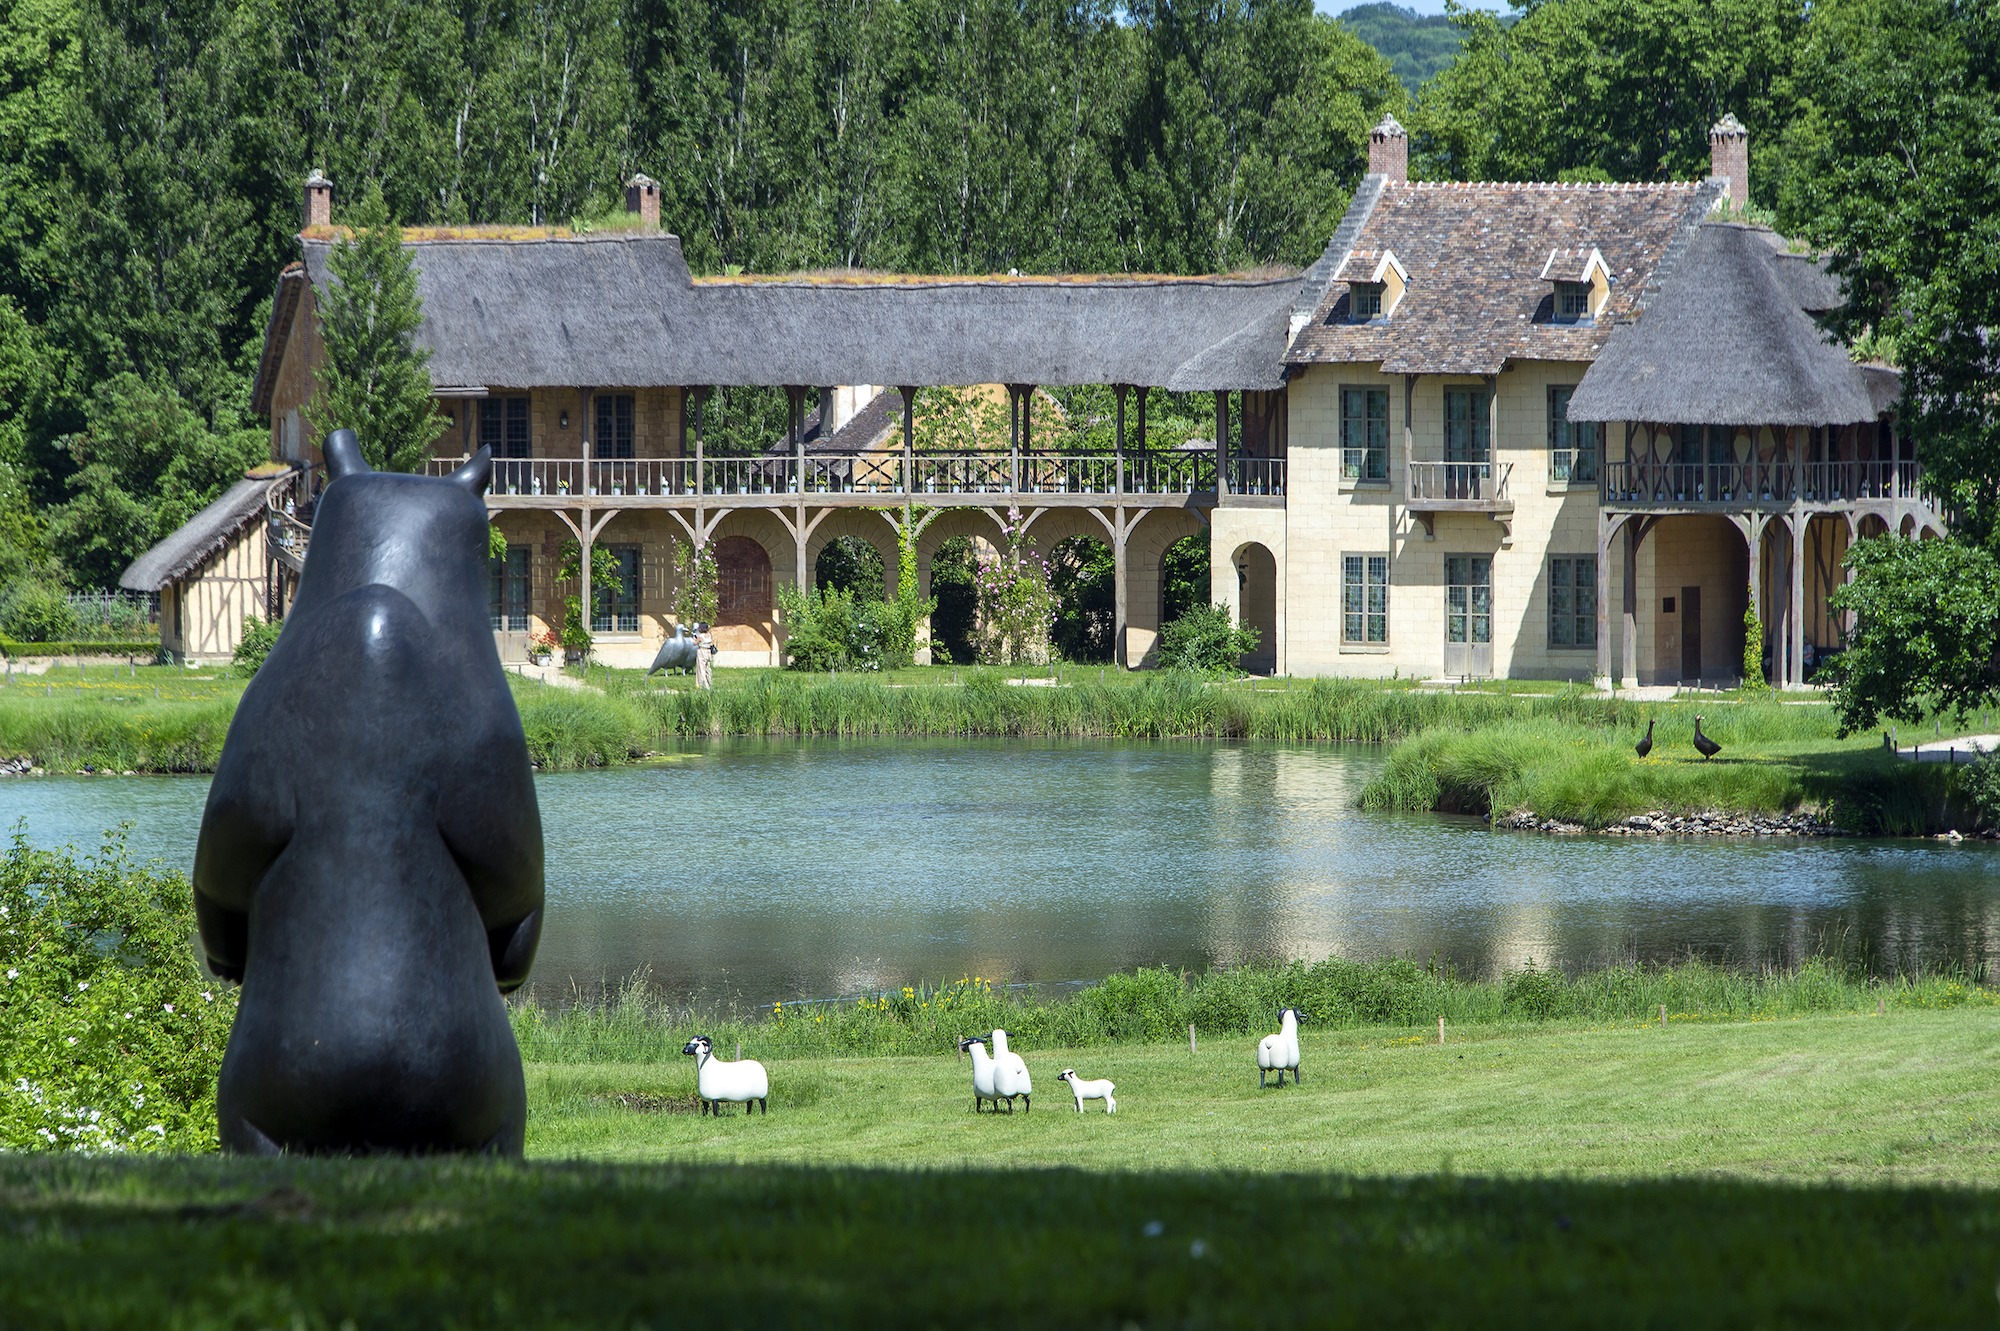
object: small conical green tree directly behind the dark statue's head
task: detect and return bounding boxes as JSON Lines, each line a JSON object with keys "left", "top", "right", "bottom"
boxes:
{"left": 306, "top": 186, "right": 444, "bottom": 472}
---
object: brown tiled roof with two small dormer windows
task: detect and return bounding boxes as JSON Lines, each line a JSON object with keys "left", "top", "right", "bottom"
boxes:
{"left": 1286, "top": 180, "right": 1722, "bottom": 374}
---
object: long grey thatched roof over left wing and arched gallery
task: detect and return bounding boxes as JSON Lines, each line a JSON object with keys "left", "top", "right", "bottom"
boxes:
{"left": 254, "top": 232, "right": 1302, "bottom": 401}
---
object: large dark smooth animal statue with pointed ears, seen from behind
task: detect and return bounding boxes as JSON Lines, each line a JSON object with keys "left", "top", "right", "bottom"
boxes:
{"left": 194, "top": 430, "right": 542, "bottom": 1155}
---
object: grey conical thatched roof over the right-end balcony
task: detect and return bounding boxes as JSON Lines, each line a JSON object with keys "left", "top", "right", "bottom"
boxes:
{"left": 1570, "top": 222, "right": 1894, "bottom": 426}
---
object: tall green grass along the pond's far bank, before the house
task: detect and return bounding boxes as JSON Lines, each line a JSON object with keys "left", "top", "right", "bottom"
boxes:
{"left": 0, "top": 666, "right": 1984, "bottom": 837}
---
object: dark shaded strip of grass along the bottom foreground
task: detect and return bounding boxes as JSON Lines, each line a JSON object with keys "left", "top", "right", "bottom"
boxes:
{"left": 0, "top": 1123, "right": 2000, "bottom": 1329}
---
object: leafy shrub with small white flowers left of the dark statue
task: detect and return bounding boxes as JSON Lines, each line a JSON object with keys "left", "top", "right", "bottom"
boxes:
{"left": 0, "top": 831, "right": 236, "bottom": 1151}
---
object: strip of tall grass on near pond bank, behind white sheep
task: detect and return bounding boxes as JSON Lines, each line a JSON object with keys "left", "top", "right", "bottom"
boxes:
{"left": 512, "top": 957, "right": 2000, "bottom": 1063}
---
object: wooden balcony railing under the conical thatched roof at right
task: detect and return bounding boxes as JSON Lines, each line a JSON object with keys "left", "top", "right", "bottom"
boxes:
{"left": 1600, "top": 460, "right": 1928, "bottom": 499}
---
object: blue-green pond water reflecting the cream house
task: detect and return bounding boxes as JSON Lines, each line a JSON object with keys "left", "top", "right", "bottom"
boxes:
{"left": 0, "top": 739, "right": 2000, "bottom": 1003}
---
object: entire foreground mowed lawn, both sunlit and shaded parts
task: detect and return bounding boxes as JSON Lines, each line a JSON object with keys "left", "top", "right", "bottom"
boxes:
{"left": 0, "top": 1009, "right": 2000, "bottom": 1327}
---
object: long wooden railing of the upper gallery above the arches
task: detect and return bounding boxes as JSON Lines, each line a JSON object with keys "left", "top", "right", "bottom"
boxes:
{"left": 426, "top": 452, "right": 1286, "bottom": 498}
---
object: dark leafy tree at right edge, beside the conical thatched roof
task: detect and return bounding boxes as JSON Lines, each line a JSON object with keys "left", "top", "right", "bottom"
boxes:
{"left": 1780, "top": 0, "right": 2000, "bottom": 550}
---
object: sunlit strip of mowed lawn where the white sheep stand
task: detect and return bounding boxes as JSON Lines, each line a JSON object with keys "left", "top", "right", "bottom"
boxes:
{"left": 528, "top": 1009, "right": 2000, "bottom": 1175}
